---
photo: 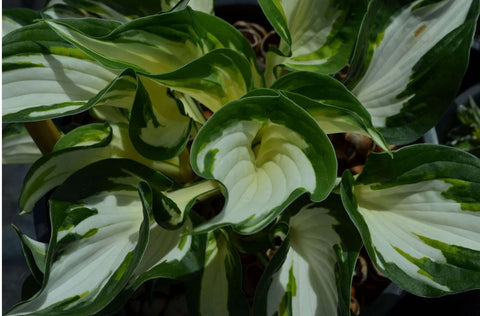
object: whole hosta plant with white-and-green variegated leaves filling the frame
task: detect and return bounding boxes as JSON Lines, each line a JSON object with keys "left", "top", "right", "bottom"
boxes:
{"left": 2, "top": 0, "right": 480, "bottom": 316}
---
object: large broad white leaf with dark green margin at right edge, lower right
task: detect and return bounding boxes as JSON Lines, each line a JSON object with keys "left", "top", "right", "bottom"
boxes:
{"left": 341, "top": 145, "right": 480, "bottom": 296}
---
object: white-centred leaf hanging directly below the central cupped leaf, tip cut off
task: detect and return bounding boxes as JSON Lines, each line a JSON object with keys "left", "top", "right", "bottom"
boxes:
{"left": 254, "top": 194, "right": 362, "bottom": 316}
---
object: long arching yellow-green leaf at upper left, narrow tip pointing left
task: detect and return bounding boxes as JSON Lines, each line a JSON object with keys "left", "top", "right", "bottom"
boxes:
{"left": 47, "top": 8, "right": 263, "bottom": 85}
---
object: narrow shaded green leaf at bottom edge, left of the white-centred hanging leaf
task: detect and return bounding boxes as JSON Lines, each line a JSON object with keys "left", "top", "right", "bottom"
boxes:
{"left": 189, "top": 229, "right": 248, "bottom": 315}
